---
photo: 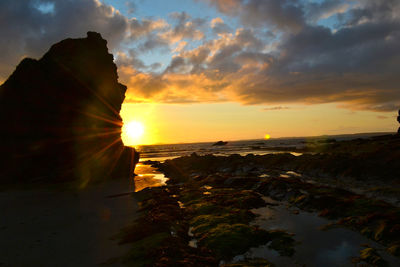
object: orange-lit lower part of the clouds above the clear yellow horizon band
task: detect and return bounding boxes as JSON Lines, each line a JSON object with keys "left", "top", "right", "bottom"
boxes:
{"left": 116, "top": 15, "right": 400, "bottom": 111}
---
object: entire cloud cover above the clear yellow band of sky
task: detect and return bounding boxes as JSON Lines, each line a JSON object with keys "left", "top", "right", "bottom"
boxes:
{"left": 0, "top": 0, "right": 400, "bottom": 112}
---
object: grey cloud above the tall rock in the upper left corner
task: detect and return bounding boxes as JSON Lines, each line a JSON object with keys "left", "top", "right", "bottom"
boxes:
{"left": 0, "top": 0, "right": 128, "bottom": 80}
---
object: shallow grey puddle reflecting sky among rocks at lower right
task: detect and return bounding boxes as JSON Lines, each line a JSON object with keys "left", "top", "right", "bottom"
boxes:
{"left": 233, "top": 198, "right": 400, "bottom": 267}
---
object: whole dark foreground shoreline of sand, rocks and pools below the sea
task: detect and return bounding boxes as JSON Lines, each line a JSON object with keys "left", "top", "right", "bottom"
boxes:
{"left": 0, "top": 137, "right": 400, "bottom": 266}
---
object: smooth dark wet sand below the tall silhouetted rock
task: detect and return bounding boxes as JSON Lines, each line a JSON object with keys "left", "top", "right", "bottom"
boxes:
{"left": 0, "top": 179, "right": 137, "bottom": 266}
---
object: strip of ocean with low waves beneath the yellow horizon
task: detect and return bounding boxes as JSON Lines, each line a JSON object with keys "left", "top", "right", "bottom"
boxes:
{"left": 137, "top": 133, "right": 388, "bottom": 161}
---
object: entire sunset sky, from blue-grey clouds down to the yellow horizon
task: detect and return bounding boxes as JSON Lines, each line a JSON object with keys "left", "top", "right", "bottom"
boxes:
{"left": 0, "top": 0, "right": 400, "bottom": 145}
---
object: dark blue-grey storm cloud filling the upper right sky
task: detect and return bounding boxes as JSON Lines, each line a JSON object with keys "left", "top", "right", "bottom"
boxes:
{"left": 181, "top": 0, "right": 394, "bottom": 111}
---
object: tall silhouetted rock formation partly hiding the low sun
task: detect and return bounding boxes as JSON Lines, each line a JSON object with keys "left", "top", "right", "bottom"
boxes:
{"left": 0, "top": 32, "right": 130, "bottom": 182}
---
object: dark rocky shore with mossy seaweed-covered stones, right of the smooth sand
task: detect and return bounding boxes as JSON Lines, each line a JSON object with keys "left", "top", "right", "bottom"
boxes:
{"left": 115, "top": 136, "right": 400, "bottom": 266}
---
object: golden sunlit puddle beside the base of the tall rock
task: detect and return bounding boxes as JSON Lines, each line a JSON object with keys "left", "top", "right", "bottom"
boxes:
{"left": 134, "top": 163, "right": 168, "bottom": 192}
